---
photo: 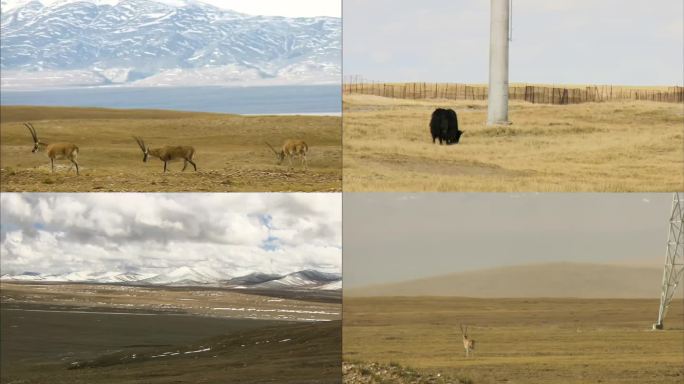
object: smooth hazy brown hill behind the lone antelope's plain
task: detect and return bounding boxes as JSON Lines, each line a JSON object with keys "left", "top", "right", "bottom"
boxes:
{"left": 344, "top": 263, "right": 682, "bottom": 298}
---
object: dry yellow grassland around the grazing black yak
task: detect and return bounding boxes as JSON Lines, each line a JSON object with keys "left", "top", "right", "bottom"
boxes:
{"left": 343, "top": 95, "right": 684, "bottom": 192}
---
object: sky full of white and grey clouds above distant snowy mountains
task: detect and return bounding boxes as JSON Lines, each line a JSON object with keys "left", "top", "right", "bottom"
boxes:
{"left": 0, "top": 193, "right": 342, "bottom": 277}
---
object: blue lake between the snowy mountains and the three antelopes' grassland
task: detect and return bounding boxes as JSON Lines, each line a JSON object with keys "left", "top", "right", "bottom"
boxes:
{"left": 0, "top": 85, "right": 342, "bottom": 114}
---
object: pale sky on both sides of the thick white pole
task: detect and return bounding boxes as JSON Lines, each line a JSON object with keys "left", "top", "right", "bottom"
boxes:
{"left": 343, "top": 0, "right": 684, "bottom": 85}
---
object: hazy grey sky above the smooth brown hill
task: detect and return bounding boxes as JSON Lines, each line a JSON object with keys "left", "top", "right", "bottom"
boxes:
{"left": 343, "top": 193, "right": 672, "bottom": 288}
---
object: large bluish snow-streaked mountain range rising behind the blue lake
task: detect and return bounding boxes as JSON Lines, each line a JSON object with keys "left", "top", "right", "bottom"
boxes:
{"left": 0, "top": 0, "right": 341, "bottom": 87}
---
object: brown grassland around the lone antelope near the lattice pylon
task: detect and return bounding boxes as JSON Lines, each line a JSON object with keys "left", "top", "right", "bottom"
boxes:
{"left": 343, "top": 296, "right": 684, "bottom": 384}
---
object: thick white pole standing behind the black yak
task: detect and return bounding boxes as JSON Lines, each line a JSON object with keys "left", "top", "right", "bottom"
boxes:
{"left": 487, "top": 0, "right": 511, "bottom": 125}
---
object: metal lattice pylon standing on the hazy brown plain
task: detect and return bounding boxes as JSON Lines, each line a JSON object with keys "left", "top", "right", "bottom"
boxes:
{"left": 653, "top": 192, "right": 684, "bottom": 329}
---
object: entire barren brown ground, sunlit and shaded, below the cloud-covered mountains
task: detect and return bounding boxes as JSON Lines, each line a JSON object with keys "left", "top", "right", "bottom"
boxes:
{"left": 0, "top": 283, "right": 341, "bottom": 384}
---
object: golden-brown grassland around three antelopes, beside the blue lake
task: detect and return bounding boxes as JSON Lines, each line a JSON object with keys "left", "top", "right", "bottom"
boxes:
{"left": 0, "top": 106, "right": 342, "bottom": 192}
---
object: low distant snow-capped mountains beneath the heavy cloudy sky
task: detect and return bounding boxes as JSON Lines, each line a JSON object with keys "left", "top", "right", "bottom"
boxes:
{"left": 0, "top": 266, "right": 342, "bottom": 290}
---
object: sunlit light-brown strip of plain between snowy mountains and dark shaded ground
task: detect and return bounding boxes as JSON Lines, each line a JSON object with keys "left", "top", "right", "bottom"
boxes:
{"left": 0, "top": 283, "right": 340, "bottom": 321}
